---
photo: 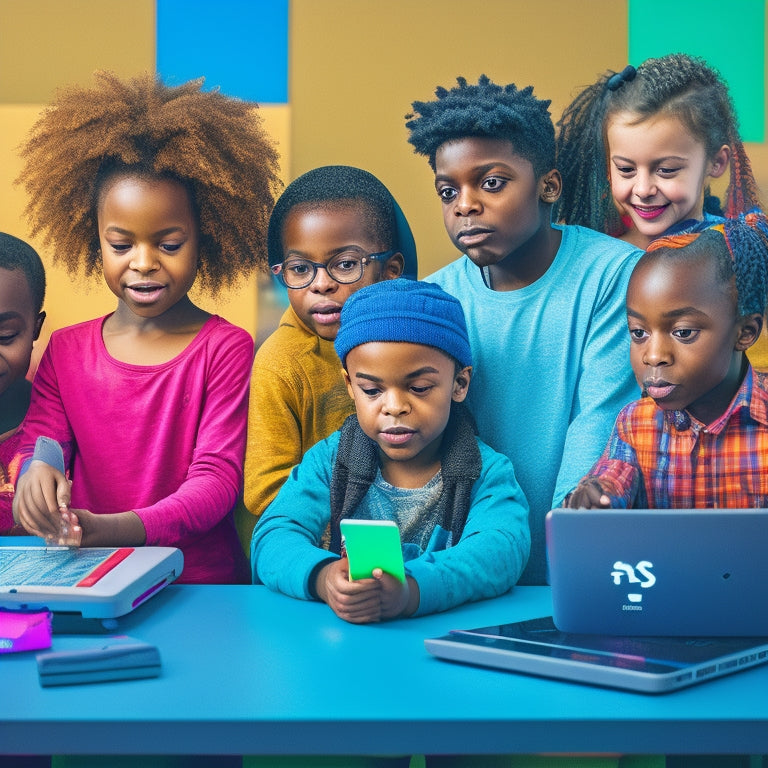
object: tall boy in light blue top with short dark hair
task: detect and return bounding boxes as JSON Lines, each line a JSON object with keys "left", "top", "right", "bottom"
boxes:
{"left": 407, "top": 76, "right": 640, "bottom": 584}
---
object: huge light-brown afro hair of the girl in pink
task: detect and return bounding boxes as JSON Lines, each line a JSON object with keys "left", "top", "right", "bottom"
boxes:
{"left": 17, "top": 72, "right": 280, "bottom": 294}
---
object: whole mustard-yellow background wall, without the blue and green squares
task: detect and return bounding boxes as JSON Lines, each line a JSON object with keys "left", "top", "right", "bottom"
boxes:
{"left": 0, "top": 0, "right": 768, "bottom": 348}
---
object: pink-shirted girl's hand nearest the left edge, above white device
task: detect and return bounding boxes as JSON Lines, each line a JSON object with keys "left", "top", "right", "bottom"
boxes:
{"left": 13, "top": 461, "right": 81, "bottom": 545}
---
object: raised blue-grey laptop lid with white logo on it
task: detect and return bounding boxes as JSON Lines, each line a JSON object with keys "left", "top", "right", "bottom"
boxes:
{"left": 545, "top": 509, "right": 768, "bottom": 637}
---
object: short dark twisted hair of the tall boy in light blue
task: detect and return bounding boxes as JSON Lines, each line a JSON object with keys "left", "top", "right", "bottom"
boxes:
{"left": 405, "top": 75, "right": 555, "bottom": 176}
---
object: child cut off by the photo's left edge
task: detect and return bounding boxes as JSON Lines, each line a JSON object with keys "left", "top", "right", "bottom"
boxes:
{"left": 0, "top": 232, "right": 45, "bottom": 535}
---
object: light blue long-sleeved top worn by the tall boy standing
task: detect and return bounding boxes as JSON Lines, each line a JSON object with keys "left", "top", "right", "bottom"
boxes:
{"left": 427, "top": 226, "right": 642, "bottom": 584}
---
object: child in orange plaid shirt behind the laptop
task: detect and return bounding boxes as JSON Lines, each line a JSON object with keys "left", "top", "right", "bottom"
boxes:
{"left": 564, "top": 213, "right": 768, "bottom": 509}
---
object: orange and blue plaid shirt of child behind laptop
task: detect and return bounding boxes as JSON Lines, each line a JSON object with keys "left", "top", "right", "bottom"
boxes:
{"left": 589, "top": 367, "right": 768, "bottom": 509}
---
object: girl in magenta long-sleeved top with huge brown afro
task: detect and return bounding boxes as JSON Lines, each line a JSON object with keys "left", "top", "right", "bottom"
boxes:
{"left": 14, "top": 72, "right": 279, "bottom": 583}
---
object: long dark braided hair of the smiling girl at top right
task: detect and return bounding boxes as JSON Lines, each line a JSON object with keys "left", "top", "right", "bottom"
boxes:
{"left": 553, "top": 53, "right": 760, "bottom": 236}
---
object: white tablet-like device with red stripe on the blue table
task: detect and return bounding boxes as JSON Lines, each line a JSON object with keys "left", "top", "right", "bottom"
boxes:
{"left": 0, "top": 545, "right": 184, "bottom": 619}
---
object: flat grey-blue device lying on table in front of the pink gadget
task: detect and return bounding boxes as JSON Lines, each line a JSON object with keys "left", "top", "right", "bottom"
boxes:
{"left": 37, "top": 635, "right": 160, "bottom": 687}
